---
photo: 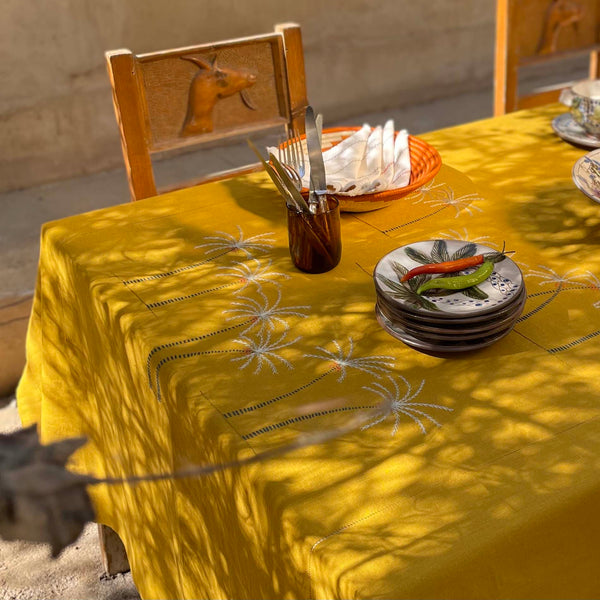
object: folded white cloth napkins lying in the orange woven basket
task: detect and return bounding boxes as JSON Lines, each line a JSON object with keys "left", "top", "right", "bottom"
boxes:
{"left": 270, "top": 119, "right": 410, "bottom": 196}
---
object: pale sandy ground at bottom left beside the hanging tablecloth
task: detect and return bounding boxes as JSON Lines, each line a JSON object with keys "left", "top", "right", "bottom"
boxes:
{"left": 0, "top": 398, "right": 140, "bottom": 600}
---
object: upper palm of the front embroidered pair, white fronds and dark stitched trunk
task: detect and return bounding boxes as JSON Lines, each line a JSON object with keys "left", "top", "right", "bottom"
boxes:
{"left": 223, "top": 338, "right": 395, "bottom": 419}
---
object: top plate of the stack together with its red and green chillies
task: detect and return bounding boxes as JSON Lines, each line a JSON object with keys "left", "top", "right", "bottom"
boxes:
{"left": 373, "top": 240, "right": 524, "bottom": 321}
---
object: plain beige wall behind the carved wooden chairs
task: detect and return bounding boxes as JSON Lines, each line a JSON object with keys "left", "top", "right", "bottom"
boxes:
{"left": 0, "top": 0, "right": 495, "bottom": 191}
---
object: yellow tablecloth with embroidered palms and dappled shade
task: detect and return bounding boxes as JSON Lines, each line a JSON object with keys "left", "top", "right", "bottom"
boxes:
{"left": 18, "top": 106, "right": 600, "bottom": 598}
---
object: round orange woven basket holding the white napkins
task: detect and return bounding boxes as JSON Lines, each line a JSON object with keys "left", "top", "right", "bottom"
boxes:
{"left": 302, "top": 127, "right": 442, "bottom": 212}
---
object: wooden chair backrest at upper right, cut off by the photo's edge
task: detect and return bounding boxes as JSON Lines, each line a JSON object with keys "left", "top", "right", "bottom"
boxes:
{"left": 494, "top": 0, "right": 600, "bottom": 115}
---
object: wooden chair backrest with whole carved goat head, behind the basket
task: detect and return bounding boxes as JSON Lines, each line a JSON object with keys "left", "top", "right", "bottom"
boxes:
{"left": 105, "top": 23, "right": 308, "bottom": 200}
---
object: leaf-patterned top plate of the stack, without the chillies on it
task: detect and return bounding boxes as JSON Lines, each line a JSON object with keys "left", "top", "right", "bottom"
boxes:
{"left": 373, "top": 240, "right": 523, "bottom": 318}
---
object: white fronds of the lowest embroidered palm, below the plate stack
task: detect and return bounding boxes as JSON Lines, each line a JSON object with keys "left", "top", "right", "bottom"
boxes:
{"left": 361, "top": 375, "right": 453, "bottom": 435}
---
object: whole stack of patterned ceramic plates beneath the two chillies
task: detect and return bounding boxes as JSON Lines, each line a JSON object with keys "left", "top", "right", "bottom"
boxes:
{"left": 373, "top": 240, "right": 527, "bottom": 354}
